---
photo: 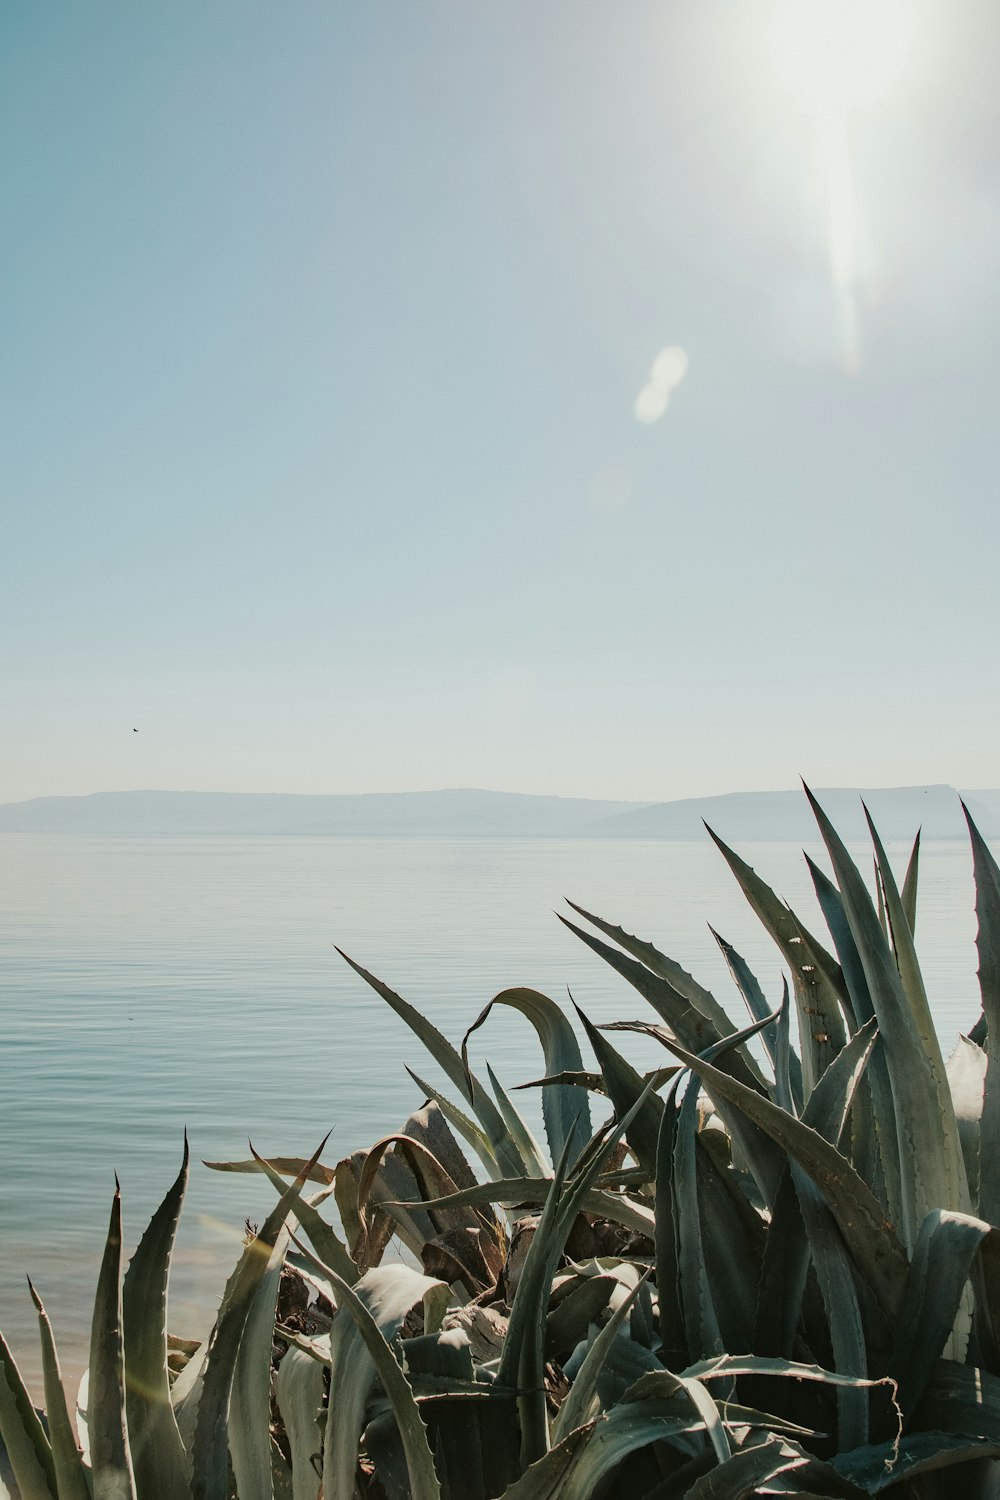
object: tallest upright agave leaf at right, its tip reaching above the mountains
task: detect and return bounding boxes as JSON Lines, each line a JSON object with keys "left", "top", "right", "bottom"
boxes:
{"left": 805, "top": 788, "right": 969, "bottom": 1247}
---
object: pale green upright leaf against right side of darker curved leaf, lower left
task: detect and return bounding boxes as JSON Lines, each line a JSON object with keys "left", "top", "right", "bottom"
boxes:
{"left": 229, "top": 1224, "right": 291, "bottom": 1500}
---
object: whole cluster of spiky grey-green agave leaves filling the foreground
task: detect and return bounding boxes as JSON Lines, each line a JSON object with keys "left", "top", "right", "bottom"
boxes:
{"left": 0, "top": 801, "right": 1000, "bottom": 1500}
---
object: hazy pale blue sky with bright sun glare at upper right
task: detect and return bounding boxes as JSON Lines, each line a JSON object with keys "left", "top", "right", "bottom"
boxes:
{"left": 0, "top": 0, "right": 1000, "bottom": 801}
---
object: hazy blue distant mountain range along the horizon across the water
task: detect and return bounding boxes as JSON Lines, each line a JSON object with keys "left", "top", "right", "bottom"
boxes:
{"left": 0, "top": 786, "right": 1000, "bottom": 843}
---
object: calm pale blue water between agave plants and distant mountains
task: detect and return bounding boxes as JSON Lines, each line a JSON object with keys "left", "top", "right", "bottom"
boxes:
{"left": 0, "top": 834, "right": 979, "bottom": 1373}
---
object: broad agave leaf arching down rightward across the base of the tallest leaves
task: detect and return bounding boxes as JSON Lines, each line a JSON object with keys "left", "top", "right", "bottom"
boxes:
{"left": 638, "top": 1043, "right": 907, "bottom": 1320}
